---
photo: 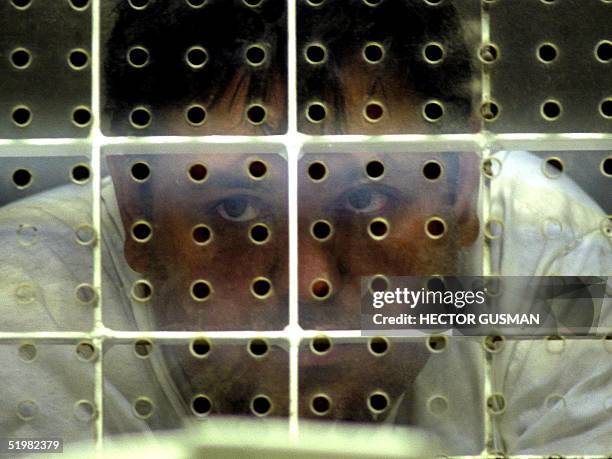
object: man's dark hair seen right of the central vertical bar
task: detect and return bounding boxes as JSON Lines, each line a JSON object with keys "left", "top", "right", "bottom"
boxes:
{"left": 298, "top": 0, "right": 479, "bottom": 130}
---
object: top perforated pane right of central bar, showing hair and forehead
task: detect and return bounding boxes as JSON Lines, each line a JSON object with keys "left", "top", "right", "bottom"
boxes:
{"left": 297, "top": 0, "right": 480, "bottom": 134}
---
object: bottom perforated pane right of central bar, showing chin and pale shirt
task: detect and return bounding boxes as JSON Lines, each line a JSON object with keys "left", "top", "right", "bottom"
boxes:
{"left": 299, "top": 335, "right": 484, "bottom": 455}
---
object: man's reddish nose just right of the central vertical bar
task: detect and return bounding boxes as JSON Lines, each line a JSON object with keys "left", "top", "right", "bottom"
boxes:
{"left": 298, "top": 228, "right": 340, "bottom": 302}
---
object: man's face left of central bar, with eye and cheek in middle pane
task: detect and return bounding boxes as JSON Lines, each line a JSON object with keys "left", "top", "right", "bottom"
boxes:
{"left": 108, "top": 154, "right": 288, "bottom": 330}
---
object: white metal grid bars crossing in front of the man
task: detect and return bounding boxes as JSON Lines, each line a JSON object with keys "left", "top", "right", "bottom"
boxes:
{"left": 0, "top": 0, "right": 612, "bottom": 458}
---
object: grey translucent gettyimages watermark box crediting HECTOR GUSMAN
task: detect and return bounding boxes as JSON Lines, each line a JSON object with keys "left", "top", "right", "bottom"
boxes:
{"left": 361, "top": 275, "right": 612, "bottom": 336}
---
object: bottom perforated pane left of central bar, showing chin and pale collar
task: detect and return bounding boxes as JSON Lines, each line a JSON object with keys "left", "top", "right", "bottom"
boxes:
{"left": 104, "top": 338, "right": 289, "bottom": 435}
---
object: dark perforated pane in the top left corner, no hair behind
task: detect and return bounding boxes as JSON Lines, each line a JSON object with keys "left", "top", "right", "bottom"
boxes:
{"left": 0, "top": 0, "right": 91, "bottom": 139}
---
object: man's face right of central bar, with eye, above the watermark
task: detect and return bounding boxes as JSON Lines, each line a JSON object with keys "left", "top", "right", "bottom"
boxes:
{"left": 299, "top": 153, "right": 479, "bottom": 329}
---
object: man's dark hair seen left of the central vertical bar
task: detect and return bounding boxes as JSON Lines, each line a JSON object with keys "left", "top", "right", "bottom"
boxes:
{"left": 102, "top": 0, "right": 287, "bottom": 134}
